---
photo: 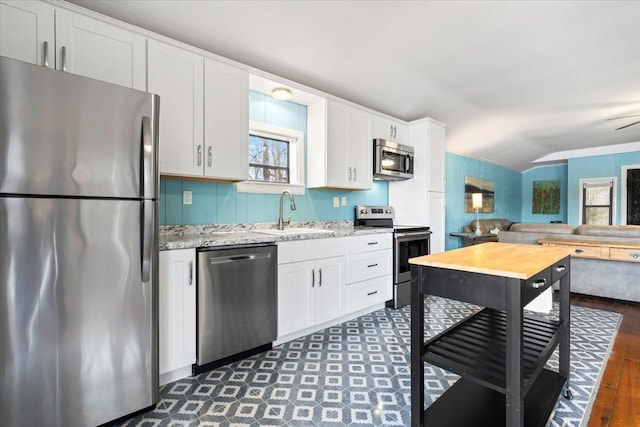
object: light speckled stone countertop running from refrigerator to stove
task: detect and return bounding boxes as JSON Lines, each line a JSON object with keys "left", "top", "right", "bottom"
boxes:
{"left": 158, "top": 221, "right": 392, "bottom": 251}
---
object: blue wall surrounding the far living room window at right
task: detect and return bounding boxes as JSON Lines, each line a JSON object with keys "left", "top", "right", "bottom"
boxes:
{"left": 567, "top": 151, "right": 640, "bottom": 225}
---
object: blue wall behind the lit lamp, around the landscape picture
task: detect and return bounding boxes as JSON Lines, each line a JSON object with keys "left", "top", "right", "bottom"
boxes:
{"left": 445, "top": 153, "right": 522, "bottom": 250}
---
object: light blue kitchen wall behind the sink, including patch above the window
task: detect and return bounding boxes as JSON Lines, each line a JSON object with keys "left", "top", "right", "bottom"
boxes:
{"left": 160, "top": 92, "right": 389, "bottom": 225}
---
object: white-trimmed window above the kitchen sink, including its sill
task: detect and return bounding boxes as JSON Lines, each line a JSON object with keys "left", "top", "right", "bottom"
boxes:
{"left": 237, "top": 122, "right": 305, "bottom": 194}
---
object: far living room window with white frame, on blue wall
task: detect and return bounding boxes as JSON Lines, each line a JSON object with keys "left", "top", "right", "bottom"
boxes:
{"left": 580, "top": 178, "right": 616, "bottom": 225}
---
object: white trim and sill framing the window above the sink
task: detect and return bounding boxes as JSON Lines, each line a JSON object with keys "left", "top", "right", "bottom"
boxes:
{"left": 236, "top": 121, "right": 305, "bottom": 196}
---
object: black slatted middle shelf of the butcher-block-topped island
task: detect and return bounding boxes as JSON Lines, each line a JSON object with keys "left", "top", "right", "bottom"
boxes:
{"left": 423, "top": 308, "right": 563, "bottom": 394}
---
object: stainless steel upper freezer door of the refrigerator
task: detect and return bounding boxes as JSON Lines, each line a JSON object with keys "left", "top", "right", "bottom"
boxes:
{"left": 0, "top": 57, "right": 159, "bottom": 199}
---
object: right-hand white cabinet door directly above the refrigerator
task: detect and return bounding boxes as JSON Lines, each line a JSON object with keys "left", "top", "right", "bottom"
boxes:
{"left": 56, "top": 9, "right": 147, "bottom": 90}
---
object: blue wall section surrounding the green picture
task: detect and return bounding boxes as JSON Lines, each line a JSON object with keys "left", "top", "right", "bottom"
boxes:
{"left": 521, "top": 165, "right": 567, "bottom": 223}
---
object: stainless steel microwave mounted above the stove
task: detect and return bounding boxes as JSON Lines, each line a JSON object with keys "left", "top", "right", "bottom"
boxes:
{"left": 373, "top": 139, "right": 413, "bottom": 181}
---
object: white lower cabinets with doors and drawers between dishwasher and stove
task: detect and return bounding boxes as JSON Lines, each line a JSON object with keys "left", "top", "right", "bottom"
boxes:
{"left": 278, "top": 233, "right": 393, "bottom": 342}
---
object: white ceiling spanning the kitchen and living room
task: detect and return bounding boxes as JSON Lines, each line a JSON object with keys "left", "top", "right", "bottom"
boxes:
{"left": 66, "top": 0, "right": 640, "bottom": 171}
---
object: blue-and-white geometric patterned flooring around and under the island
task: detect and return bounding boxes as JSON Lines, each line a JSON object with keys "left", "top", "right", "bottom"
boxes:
{"left": 115, "top": 296, "right": 622, "bottom": 427}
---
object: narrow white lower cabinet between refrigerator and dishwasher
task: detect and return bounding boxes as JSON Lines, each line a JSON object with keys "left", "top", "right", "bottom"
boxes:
{"left": 159, "top": 249, "right": 196, "bottom": 381}
